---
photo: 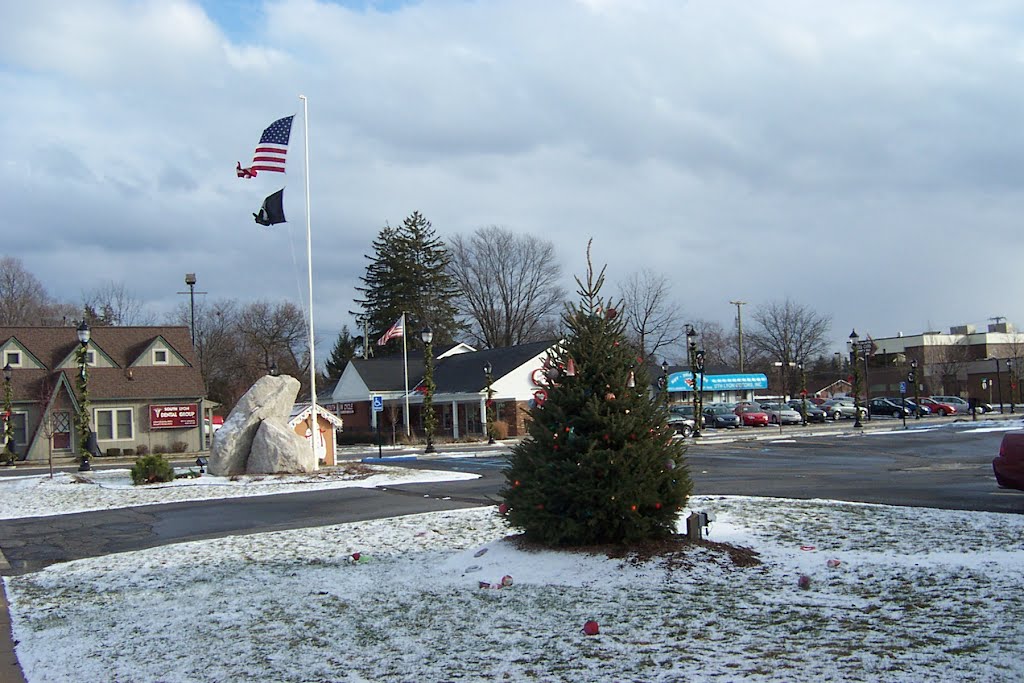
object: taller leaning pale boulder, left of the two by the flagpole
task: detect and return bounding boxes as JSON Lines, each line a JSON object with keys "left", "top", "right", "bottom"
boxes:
{"left": 210, "top": 375, "right": 299, "bottom": 476}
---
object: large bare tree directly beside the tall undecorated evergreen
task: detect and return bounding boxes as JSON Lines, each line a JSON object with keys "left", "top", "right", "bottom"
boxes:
{"left": 449, "top": 225, "right": 565, "bottom": 348}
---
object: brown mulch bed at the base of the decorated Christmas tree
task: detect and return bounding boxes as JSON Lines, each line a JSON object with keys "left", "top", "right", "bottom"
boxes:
{"left": 506, "top": 533, "right": 761, "bottom": 570}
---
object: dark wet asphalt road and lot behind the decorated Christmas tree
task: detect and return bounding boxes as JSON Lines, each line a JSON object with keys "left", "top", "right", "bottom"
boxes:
{"left": 0, "top": 422, "right": 1024, "bottom": 573}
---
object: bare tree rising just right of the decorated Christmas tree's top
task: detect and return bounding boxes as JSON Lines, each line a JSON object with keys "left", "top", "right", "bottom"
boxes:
{"left": 620, "top": 268, "right": 686, "bottom": 358}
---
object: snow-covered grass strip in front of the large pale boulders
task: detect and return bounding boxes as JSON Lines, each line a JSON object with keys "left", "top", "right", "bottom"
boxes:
{"left": 0, "top": 463, "right": 478, "bottom": 519}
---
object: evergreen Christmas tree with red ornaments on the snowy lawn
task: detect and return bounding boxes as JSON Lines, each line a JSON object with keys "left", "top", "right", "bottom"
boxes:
{"left": 501, "top": 247, "right": 691, "bottom": 546}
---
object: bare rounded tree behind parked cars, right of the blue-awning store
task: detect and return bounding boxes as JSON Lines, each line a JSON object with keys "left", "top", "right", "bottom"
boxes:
{"left": 744, "top": 299, "right": 831, "bottom": 391}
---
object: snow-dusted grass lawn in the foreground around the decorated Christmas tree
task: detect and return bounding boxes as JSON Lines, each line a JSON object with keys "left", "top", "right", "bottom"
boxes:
{"left": 5, "top": 497, "right": 1024, "bottom": 683}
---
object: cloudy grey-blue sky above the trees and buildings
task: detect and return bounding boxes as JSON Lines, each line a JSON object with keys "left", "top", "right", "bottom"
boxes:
{"left": 0, "top": 0, "right": 1024, "bottom": 357}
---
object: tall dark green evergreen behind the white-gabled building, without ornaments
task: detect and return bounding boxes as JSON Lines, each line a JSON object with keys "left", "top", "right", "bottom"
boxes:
{"left": 355, "top": 211, "right": 460, "bottom": 348}
